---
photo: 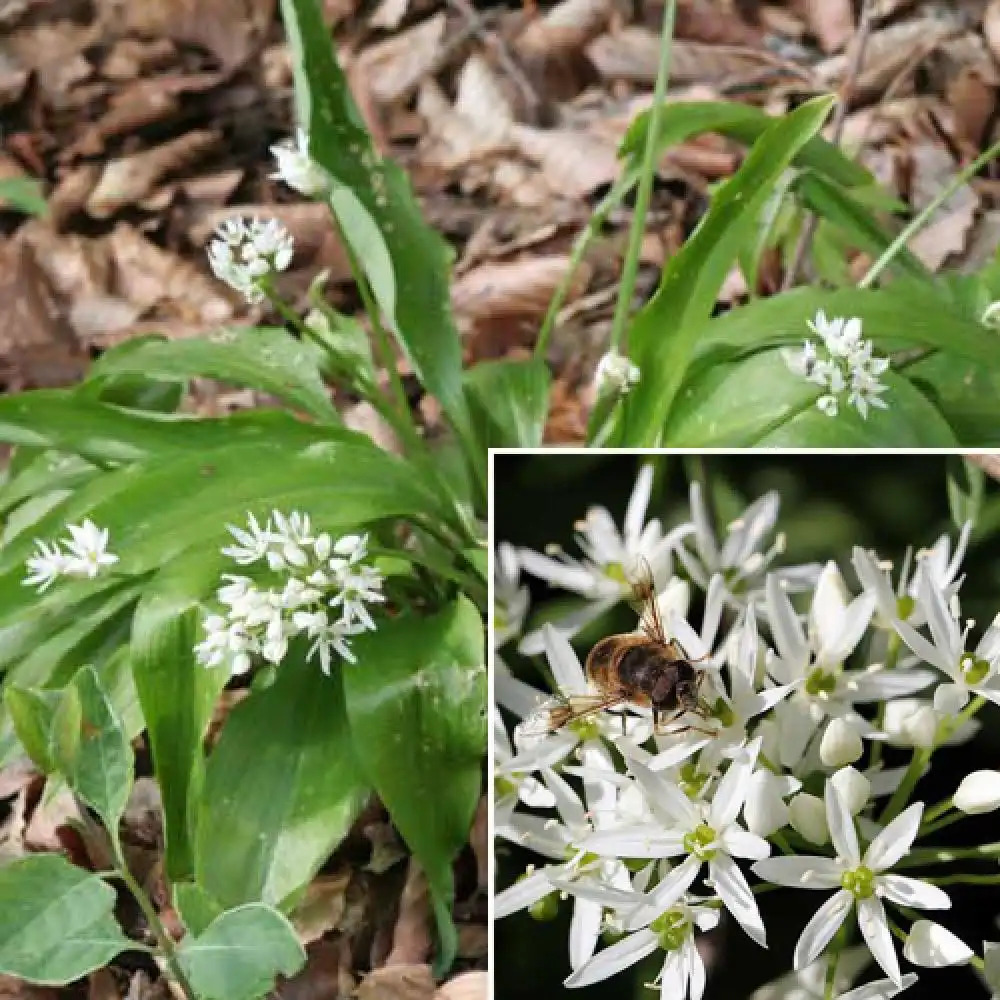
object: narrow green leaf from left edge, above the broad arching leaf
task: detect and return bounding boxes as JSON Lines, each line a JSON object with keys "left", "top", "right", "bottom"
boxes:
{"left": 0, "top": 389, "right": 363, "bottom": 463}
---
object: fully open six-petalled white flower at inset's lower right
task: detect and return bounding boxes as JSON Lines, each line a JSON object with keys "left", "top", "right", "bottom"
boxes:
{"left": 753, "top": 782, "right": 951, "bottom": 986}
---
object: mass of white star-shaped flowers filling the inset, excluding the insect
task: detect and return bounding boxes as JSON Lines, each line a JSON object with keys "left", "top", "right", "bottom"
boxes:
{"left": 493, "top": 470, "right": 1000, "bottom": 1000}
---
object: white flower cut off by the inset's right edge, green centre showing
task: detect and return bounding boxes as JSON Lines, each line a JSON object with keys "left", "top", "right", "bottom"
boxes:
{"left": 895, "top": 572, "right": 1000, "bottom": 715}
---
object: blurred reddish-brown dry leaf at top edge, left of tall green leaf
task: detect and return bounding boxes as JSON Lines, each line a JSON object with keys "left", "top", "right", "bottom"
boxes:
{"left": 97, "top": 0, "right": 275, "bottom": 68}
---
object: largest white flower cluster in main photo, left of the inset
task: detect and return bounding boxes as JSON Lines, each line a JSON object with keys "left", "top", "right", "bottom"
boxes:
{"left": 195, "top": 510, "right": 384, "bottom": 674}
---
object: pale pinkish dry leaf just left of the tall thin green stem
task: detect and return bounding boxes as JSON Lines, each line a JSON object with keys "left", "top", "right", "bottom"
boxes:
{"left": 510, "top": 125, "right": 622, "bottom": 200}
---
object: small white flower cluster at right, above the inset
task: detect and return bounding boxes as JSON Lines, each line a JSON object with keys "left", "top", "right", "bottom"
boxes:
{"left": 782, "top": 310, "right": 889, "bottom": 419}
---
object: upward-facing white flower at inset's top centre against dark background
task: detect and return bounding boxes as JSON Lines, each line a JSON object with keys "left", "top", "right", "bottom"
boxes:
{"left": 676, "top": 482, "right": 819, "bottom": 604}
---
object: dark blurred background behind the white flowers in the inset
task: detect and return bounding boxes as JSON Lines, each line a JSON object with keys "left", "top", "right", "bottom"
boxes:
{"left": 493, "top": 453, "right": 1000, "bottom": 1000}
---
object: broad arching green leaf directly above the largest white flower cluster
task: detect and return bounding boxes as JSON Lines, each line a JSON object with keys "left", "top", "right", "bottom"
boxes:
{"left": 0, "top": 441, "right": 456, "bottom": 580}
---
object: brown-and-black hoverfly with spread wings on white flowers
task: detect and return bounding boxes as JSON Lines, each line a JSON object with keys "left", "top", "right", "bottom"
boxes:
{"left": 522, "top": 559, "right": 707, "bottom": 734}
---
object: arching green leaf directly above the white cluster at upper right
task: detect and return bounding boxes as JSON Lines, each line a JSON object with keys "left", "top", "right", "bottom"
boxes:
{"left": 697, "top": 282, "right": 1000, "bottom": 370}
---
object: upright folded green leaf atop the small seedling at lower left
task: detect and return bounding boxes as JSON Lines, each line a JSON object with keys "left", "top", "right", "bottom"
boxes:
{"left": 59, "top": 667, "right": 133, "bottom": 831}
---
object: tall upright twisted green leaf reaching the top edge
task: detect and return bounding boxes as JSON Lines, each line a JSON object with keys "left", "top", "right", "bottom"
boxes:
{"left": 281, "top": 0, "right": 469, "bottom": 442}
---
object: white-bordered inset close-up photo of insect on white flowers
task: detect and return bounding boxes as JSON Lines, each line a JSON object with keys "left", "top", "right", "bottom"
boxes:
{"left": 491, "top": 452, "right": 1000, "bottom": 1000}
